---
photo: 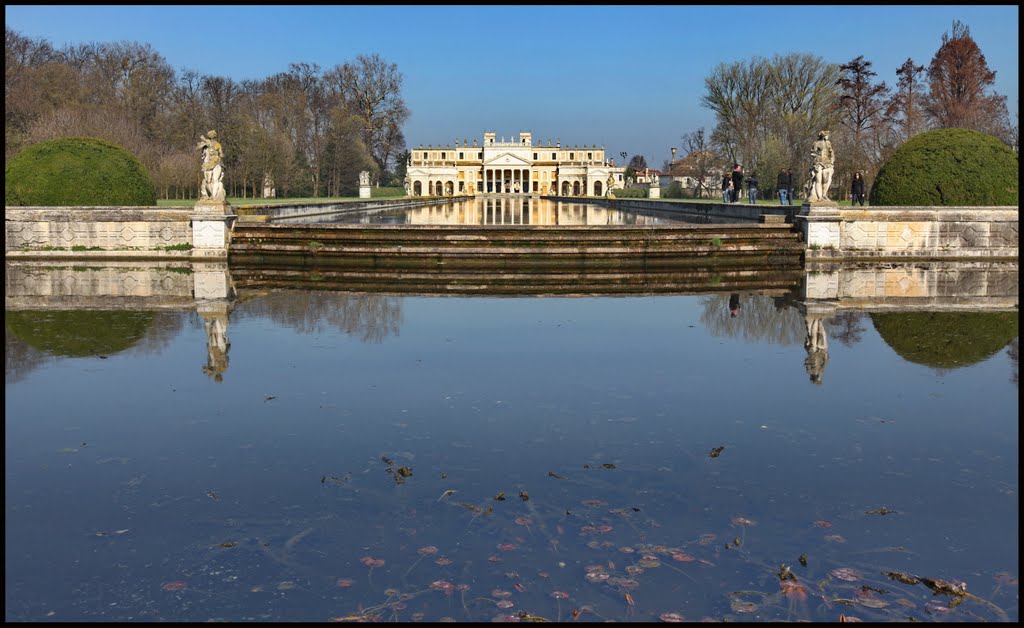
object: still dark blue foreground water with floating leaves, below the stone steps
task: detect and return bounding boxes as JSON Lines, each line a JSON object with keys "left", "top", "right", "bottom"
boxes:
{"left": 4, "top": 284, "right": 1019, "bottom": 621}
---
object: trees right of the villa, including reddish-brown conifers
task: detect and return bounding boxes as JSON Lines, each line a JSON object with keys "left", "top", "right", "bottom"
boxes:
{"left": 666, "top": 22, "right": 1020, "bottom": 198}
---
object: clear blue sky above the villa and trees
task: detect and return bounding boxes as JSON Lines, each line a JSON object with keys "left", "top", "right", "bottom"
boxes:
{"left": 4, "top": 5, "right": 1019, "bottom": 167}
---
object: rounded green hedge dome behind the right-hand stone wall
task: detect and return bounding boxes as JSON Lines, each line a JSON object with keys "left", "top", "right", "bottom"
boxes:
{"left": 869, "top": 129, "right": 1018, "bottom": 206}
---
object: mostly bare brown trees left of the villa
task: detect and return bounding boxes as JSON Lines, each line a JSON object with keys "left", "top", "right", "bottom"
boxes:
{"left": 4, "top": 28, "right": 410, "bottom": 198}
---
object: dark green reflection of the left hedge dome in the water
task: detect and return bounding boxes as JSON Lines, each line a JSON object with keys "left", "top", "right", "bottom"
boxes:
{"left": 4, "top": 309, "right": 154, "bottom": 358}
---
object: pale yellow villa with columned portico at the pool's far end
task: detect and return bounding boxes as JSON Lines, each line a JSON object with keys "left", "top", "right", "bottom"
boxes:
{"left": 407, "top": 131, "right": 626, "bottom": 197}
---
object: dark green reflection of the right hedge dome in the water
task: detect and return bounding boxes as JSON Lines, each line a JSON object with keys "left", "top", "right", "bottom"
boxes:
{"left": 871, "top": 311, "right": 1017, "bottom": 369}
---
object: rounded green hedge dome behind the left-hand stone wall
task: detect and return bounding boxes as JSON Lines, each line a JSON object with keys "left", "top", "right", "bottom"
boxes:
{"left": 4, "top": 137, "right": 157, "bottom": 207}
